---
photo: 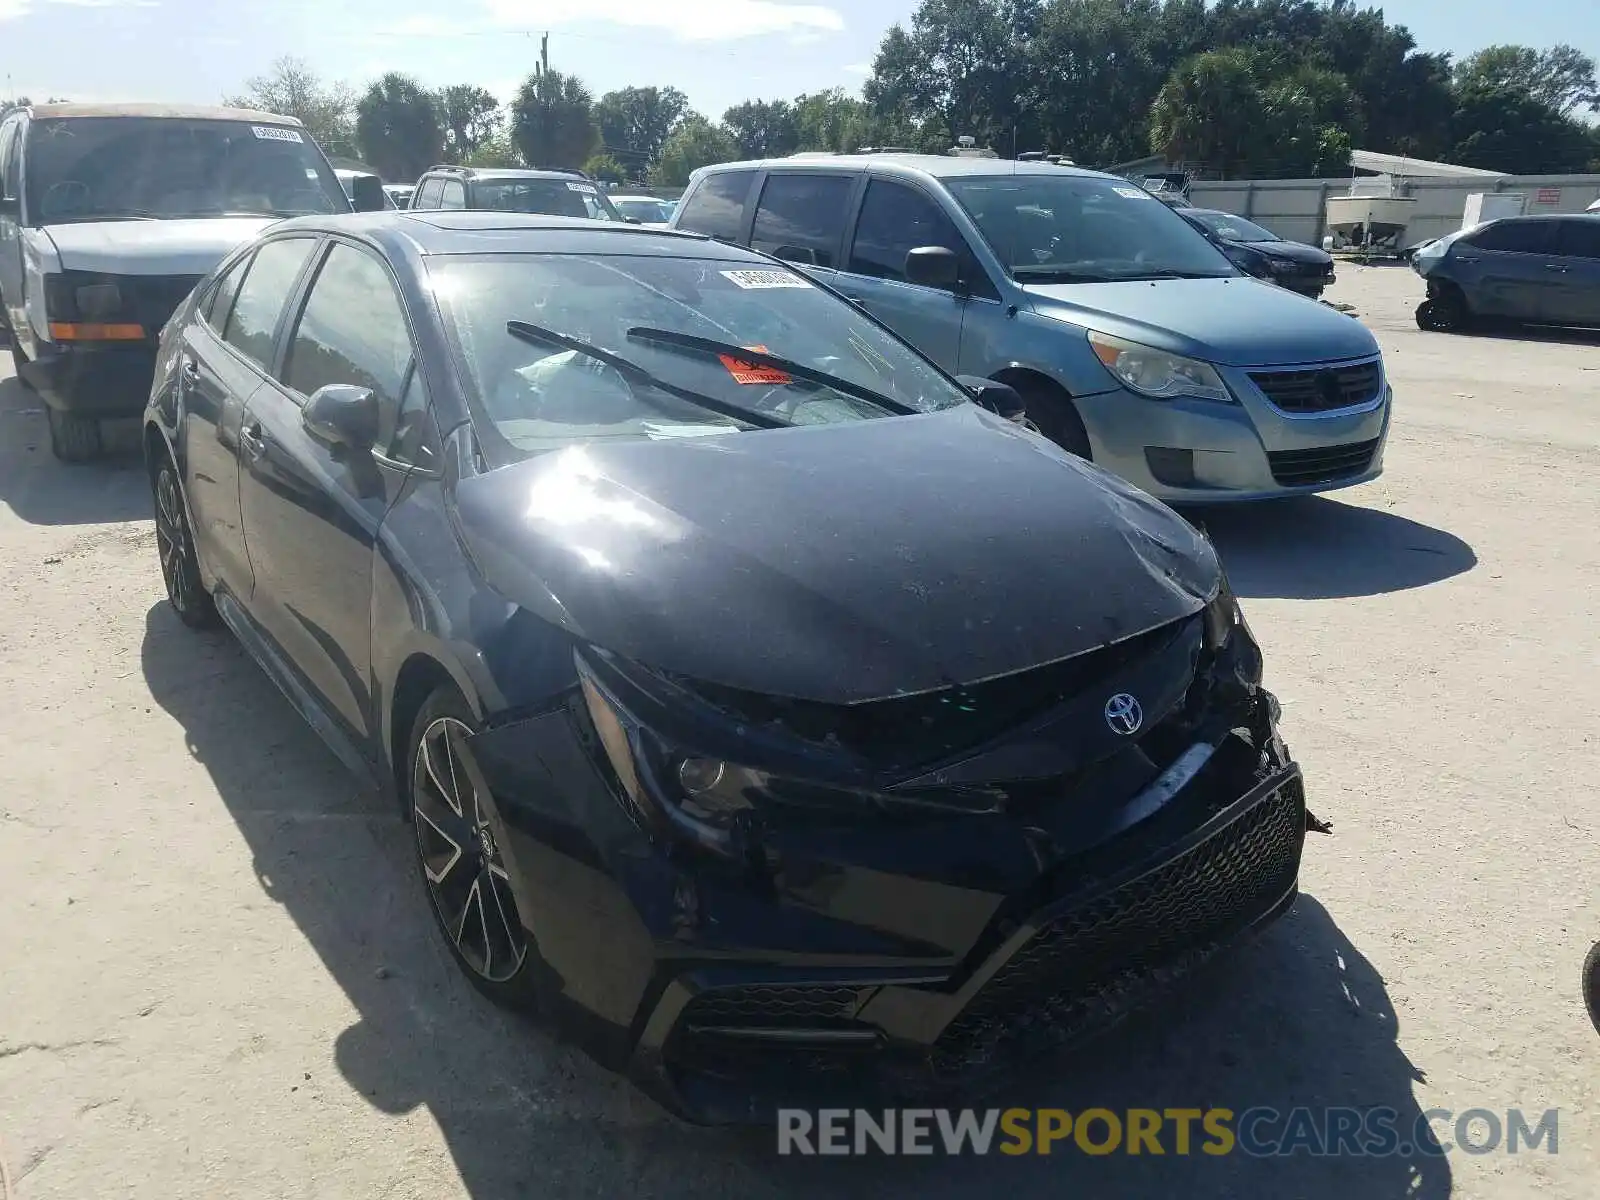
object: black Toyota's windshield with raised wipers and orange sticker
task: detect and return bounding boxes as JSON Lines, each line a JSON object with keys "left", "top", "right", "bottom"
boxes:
{"left": 429, "top": 254, "right": 970, "bottom": 458}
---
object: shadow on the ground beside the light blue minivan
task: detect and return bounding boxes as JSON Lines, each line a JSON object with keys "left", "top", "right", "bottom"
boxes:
{"left": 1184, "top": 496, "right": 1478, "bottom": 600}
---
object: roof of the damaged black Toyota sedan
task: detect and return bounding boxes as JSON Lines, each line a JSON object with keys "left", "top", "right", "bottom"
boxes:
{"left": 270, "top": 208, "right": 771, "bottom": 259}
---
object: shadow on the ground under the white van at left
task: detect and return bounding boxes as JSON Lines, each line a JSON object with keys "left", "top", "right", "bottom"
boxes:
{"left": 0, "top": 376, "right": 150, "bottom": 525}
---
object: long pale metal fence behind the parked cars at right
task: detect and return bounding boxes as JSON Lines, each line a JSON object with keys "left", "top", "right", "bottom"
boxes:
{"left": 1189, "top": 174, "right": 1600, "bottom": 246}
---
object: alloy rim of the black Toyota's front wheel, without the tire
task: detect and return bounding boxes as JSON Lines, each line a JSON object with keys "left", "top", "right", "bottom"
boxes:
{"left": 411, "top": 717, "right": 528, "bottom": 984}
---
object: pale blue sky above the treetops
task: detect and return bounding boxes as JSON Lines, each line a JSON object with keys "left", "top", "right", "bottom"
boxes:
{"left": 0, "top": 0, "right": 1600, "bottom": 115}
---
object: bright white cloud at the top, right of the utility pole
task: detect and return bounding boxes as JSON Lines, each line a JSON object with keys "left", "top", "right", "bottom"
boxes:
{"left": 385, "top": 0, "right": 845, "bottom": 42}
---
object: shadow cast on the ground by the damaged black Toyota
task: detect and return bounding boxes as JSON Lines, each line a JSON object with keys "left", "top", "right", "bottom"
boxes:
{"left": 142, "top": 603, "right": 1450, "bottom": 1200}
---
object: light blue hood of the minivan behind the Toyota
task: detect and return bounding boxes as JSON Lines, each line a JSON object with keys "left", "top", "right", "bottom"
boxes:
{"left": 1026, "top": 277, "right": 1378, "bottom": 366}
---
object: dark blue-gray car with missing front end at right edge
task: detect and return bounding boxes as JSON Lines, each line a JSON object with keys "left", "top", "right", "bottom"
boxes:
{"left": 1411, "top": 214, "right": 1600, "bottom": 333}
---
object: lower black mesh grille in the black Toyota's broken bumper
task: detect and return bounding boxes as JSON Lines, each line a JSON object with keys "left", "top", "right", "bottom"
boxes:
{"left": 934, "top": 774, "right": 1306, "bottom": 1072}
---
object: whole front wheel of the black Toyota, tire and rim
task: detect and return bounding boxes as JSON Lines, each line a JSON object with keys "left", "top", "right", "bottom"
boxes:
{"left": 405, "top": 686, "right": 536, "bottom": 1010}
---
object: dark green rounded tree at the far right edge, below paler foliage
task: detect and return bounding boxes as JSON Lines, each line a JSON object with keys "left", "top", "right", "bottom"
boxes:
{"left": 1450, "top": 86, "right": 1595, "bottom": 174}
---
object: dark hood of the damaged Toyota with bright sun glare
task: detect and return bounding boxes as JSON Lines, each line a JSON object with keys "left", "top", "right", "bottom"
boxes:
{"left": 454, "top": 405, "right": 1219, "bottom": 704}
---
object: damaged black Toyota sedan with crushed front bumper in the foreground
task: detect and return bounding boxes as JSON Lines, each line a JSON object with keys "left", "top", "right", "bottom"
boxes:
{"left": 146, "top": 211, "right": 1307, "bottom": 1120}
